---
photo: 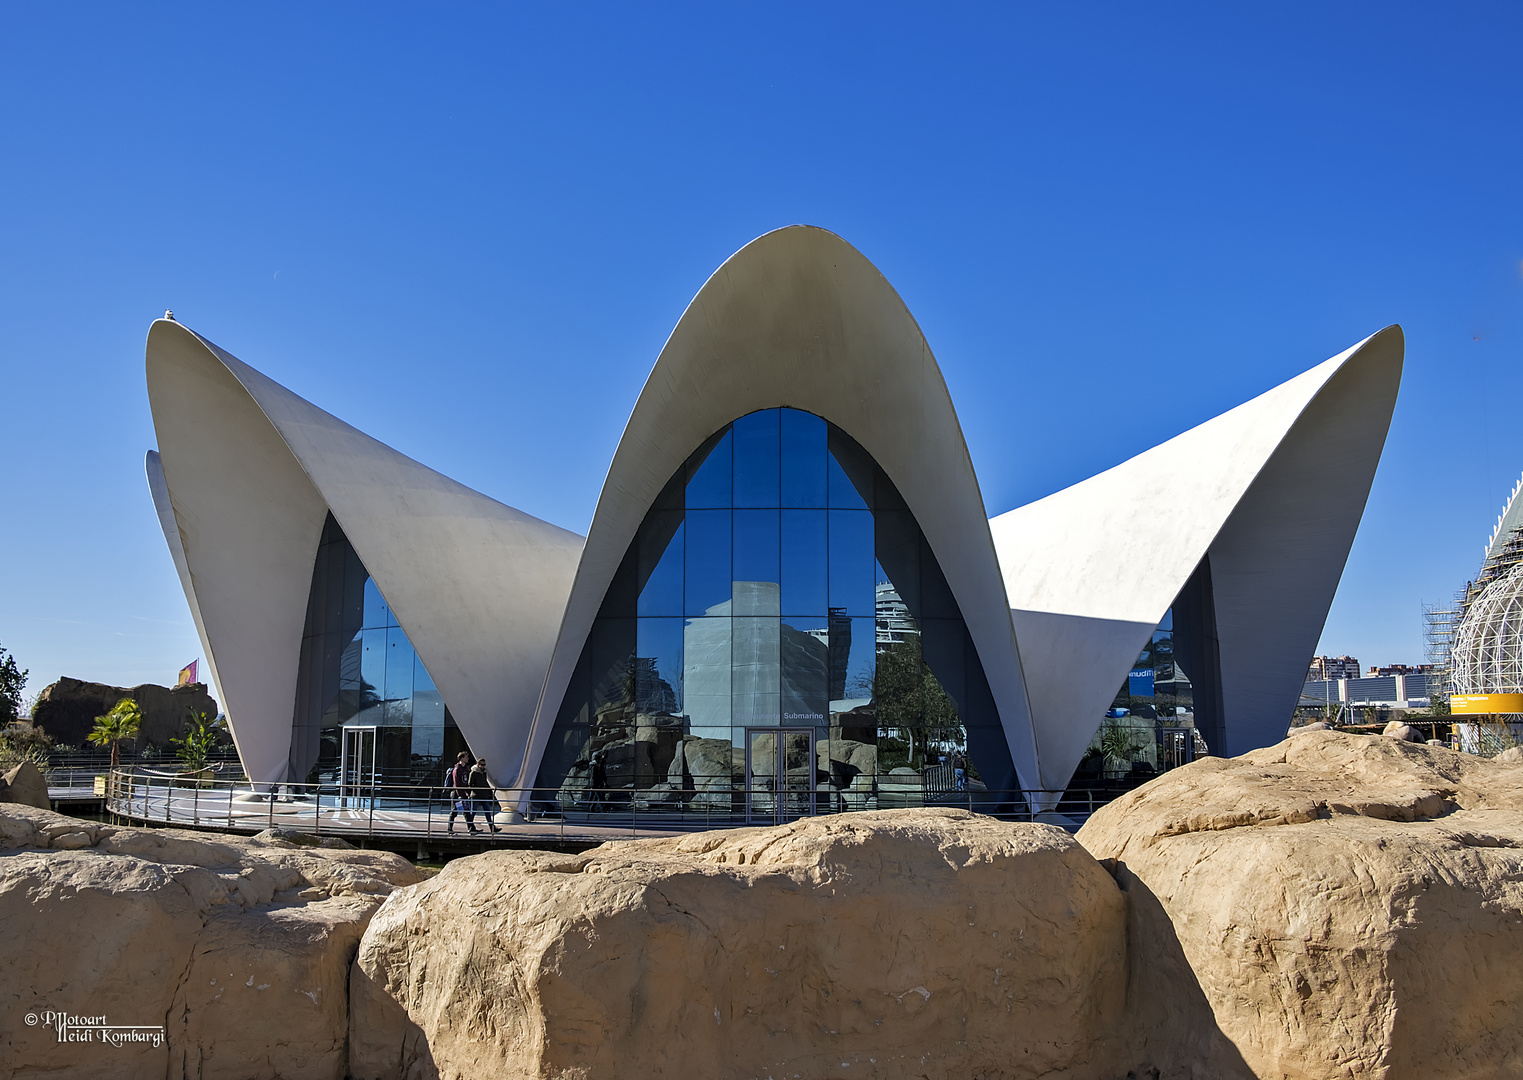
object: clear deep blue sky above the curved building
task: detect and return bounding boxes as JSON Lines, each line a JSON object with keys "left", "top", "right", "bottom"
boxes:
{"left": 0, "top": 3, "right": 1523, "bottom": 690}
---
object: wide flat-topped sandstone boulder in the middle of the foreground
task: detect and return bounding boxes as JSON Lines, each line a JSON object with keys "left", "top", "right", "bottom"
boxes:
{"left": 350, "top": 810, "right": 1125, "bottom": 1080}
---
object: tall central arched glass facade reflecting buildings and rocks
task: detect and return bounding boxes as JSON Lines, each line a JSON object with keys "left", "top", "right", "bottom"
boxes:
{"left": 536, "top": 408, "right": 1016, "bottom": 818}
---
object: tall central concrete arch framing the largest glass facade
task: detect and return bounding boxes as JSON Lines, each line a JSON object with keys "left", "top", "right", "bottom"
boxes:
{"left": 515, "top": 225, "right": 1039, "bottom": 786}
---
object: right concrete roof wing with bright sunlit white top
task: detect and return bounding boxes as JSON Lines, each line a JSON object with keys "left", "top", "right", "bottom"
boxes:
{"left": 990, "top": 326, "right": 1403, "bottom": 789}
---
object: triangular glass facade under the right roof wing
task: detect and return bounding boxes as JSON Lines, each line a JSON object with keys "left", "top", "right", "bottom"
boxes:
{"left": 1075, "top": 556, "right": 1224, "bottom": 784}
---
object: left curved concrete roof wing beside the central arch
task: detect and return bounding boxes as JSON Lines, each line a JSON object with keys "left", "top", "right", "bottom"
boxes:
{"left": 146, "top": 320, "right": 582, "bottom": 783}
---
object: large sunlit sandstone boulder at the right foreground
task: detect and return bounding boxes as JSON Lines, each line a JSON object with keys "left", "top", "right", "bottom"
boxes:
{"left": 1078, "top": 731, "right": 1523, "bottom": 1080}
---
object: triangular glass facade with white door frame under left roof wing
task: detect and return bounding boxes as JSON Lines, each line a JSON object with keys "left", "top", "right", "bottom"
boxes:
{"left": 289, "top": 515, "right": 465, "bottom": 784}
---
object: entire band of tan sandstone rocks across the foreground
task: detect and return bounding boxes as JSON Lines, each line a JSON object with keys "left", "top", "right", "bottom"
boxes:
{"left": 0, "top": 731, "right": 1523, "bottom": 1080}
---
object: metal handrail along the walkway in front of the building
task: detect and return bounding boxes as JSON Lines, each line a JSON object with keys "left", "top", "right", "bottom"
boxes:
{"left": 105, "top": 765, "right": 1109, "bottom": 848}
